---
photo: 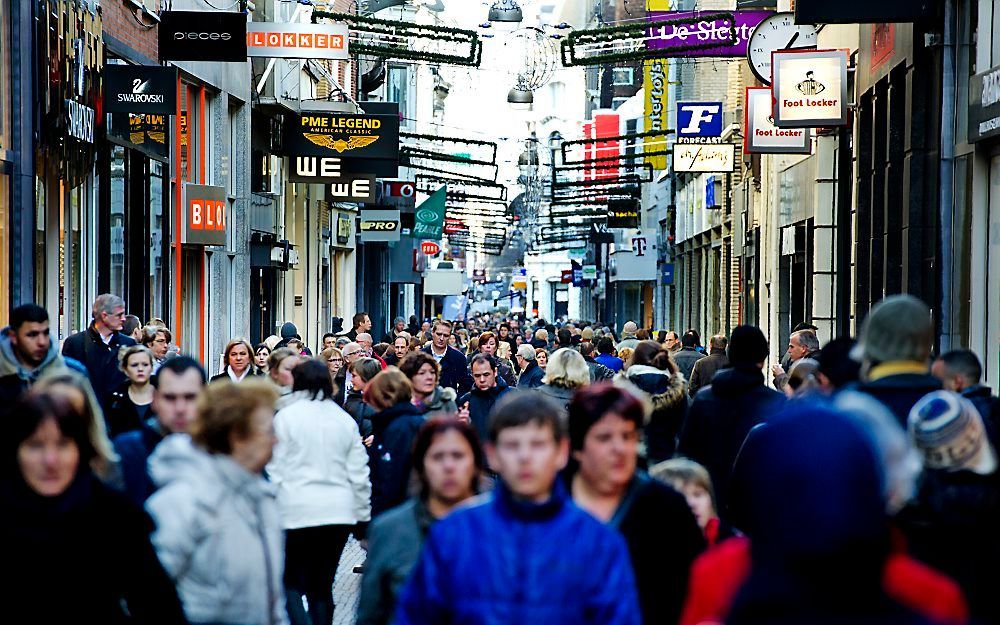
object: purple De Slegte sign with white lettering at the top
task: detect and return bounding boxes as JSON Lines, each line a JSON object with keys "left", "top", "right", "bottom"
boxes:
{"left": 646, "top": 11, "right": 773, "bottom": 57}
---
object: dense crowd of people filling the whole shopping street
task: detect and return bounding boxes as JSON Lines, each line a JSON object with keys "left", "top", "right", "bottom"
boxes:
{"left": 0, "top": 295, "right": 1000, "bottom": 625}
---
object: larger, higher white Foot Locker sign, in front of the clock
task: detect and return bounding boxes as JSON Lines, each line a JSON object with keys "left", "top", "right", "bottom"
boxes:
{"left": 771, "top": 50, "right": 849, "bottom": 128}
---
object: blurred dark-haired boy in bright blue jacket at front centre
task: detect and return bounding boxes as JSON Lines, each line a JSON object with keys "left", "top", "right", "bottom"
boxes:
{"left": 396, "top": 391, "right": 642, "bottom": 625}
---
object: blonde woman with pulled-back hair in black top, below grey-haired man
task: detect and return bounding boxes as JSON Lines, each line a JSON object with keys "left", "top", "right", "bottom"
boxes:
{"left": 104, "top": 345, "right": 156, "bottom": 438}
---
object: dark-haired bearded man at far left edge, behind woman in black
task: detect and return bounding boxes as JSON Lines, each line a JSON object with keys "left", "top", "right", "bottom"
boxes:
{"left": 0, "top": 304, "right": 67, "bottom": 420}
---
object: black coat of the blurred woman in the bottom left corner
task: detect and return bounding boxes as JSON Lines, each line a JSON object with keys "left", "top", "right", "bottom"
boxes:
{"left": 0, "top": 471, "right": 187, "bottom": 625}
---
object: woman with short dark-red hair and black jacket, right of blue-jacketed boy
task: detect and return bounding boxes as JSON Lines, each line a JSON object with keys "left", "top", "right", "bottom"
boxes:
{"left": 568, "top": 386, "right": 705, "bottom": 623}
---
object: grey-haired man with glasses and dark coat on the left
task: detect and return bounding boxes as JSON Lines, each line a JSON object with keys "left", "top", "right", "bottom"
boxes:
{"left": 63, "top": 293, "right": 136, "bottom": 410}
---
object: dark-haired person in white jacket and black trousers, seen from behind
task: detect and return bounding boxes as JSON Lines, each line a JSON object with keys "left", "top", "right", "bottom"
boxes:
{"left": 267, "top": 359, "right": 378, "bottom": 625}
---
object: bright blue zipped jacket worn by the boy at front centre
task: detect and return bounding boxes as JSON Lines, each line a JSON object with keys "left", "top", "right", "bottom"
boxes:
{"left": 395, "top": 481, "right": 642, "bottom": 625}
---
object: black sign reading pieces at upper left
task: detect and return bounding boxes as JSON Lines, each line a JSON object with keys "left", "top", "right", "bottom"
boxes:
{"left": 159, "top": 11, "right": 247, "bottom": 63}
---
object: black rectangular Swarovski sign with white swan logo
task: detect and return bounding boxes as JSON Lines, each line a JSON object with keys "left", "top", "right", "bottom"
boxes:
{"left": 104, "top": 65, "right": 177, "bottom": 115}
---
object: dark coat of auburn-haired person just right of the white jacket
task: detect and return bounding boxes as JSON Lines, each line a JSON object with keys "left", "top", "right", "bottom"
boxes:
{"left": 371, "top": 401, "right": 424, "bottom": 518}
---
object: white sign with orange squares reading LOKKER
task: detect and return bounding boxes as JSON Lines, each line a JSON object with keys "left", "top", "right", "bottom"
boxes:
{"left": 247, "top": 22, "right": 350, "bottom": 61}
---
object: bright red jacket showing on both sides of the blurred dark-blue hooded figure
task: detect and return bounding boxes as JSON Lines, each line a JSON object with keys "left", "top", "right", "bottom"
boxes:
{"left": 680, "top": 536, "right": 969, "bottom": 625}
